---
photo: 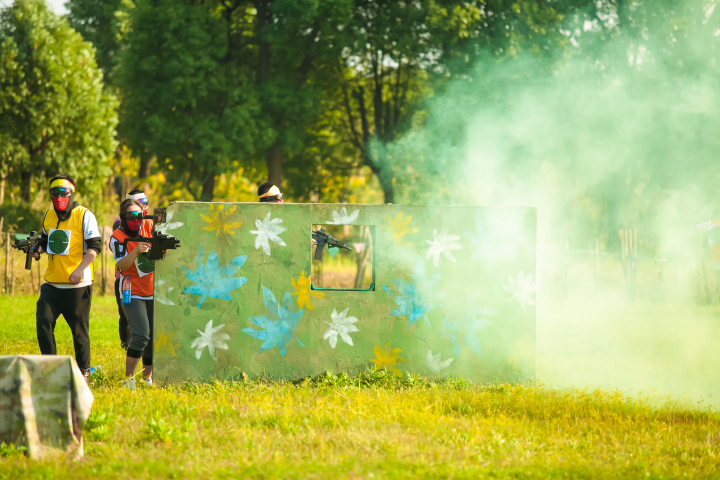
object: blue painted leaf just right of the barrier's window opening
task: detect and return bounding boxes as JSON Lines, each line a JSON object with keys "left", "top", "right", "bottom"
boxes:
{"left": 382, "top": 260, "right": 441, "bottom": 327}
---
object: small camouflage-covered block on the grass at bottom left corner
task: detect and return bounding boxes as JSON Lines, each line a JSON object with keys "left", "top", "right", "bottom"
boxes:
{"left": 0, "top": 355, "right": 93, "bottom": 458}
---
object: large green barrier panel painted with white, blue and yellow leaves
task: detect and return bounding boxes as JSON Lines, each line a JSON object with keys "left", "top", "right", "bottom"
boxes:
{"left": 154, "top": 202, "right": 536, "bottom": 382}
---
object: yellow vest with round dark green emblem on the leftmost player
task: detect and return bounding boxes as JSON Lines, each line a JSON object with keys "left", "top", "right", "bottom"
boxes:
{"left": 43, "top": 206, "right": 94, "bottom": 283}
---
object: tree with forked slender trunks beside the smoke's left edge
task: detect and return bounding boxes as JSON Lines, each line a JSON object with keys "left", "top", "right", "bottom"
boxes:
{"left": 334, "top": 0, "right": 560, "bottom": 203}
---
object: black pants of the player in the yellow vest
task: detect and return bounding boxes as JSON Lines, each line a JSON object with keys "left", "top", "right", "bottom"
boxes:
{"left": 35, "top": 283, "right": 92, "bottom": 370}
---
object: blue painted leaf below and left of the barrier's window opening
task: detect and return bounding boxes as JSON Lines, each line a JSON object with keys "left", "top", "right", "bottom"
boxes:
{"left": 243, "top": 287, "right": 305, "bottom": 356}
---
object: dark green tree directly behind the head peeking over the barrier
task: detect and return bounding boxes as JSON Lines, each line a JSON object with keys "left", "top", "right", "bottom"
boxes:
{"left": 252, "top": 0, "right": 351, "bottom": 185}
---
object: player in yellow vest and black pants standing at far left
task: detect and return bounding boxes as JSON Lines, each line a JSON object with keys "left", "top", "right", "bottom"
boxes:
{"left": 35, "top": 175, "right": 102, "bottom": 379}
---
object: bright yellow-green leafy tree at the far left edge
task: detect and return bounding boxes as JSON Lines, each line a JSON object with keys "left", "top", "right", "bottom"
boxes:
{"left": 0, "top": 0, "right": 117, "bottom": 201}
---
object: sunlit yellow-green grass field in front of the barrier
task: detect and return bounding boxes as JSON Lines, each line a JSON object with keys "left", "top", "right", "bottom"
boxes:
{"left": 0, "top": 297, "right": 720, "bottom": 479}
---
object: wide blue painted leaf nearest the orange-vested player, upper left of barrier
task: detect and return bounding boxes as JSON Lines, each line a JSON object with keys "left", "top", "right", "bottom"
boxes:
{"left": 180, "top": 245, "right": 247, "bottom": 308}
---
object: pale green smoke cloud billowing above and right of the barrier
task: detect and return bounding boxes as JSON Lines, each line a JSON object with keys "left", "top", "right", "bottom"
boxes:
{"left": 373, "top": 0, "right": 720, "bottom": 406}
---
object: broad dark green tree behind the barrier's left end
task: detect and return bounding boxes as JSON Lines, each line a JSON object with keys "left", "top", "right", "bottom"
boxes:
{"left": 118, "top": 0, "right": 266, "bottom": 201}
